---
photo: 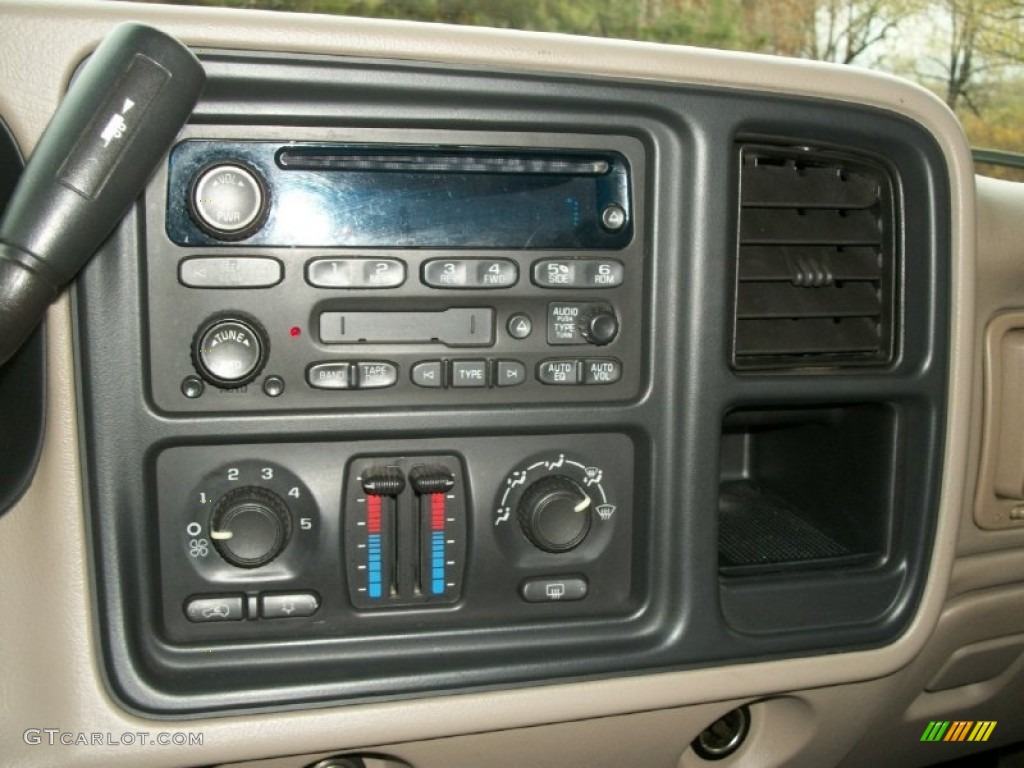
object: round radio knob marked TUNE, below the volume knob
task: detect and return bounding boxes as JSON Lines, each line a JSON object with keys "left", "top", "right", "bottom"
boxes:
{"left": 191, "top": 312, "right": 269, "bottom": 389}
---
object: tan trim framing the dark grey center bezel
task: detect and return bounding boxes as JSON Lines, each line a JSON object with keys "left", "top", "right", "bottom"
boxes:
{"left": 0, "top": 0, "right": 975, "bottom": 768}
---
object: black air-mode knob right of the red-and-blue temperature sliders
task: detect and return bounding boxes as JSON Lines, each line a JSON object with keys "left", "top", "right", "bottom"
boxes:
{"left": 518, "top": 475, "right": 592, "bottom": 552}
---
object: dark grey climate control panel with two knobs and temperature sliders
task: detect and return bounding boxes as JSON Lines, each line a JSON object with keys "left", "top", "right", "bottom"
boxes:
{"left": 156, "top": 434, "right": 634, "bottom": 640}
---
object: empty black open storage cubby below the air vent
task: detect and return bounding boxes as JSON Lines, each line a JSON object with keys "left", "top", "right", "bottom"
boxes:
{"left": 718, "top": 403, "right": 896, "bottom": 577}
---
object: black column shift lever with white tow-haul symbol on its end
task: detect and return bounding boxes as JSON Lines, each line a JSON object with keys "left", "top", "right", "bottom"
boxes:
{"left": 0, "top": 24, "right": 206, "bottom": 365}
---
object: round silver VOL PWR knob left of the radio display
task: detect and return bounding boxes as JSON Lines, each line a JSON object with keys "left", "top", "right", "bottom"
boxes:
{"left": 188, "top": 163, "right": 267, "bottom": 240}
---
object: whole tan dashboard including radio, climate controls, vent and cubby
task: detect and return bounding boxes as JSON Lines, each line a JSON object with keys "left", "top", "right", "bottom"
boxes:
{"left": 0, "top": 2, "right": 1024, "bottom": 768}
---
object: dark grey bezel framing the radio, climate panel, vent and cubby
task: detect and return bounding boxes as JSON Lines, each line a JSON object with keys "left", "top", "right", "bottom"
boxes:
{"left": 74, "top": 51, "right": 951, "bottom": 716}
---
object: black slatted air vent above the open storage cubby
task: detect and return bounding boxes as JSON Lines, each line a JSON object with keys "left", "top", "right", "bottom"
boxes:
{"left": 733, "top": 144, "right": 897, "bottom": 370}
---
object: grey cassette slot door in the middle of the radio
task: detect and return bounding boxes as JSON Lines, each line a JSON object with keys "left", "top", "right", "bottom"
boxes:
{"left": 319, "top": 307, "right": 495, "bottom": 347}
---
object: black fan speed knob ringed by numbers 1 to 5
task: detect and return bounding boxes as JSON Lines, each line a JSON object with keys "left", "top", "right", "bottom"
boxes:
{"left": 210, "top": 485, "right": 292, "bottom": 568}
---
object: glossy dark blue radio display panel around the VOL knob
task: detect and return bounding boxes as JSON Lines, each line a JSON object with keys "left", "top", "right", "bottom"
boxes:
{"left": 167, "top": 140, "right": 633, "bottom": 250}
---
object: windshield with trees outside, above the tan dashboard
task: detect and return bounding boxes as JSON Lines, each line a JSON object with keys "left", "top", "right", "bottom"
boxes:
{"left": 123, "top": 0, "right": 1024, "bottom": 180}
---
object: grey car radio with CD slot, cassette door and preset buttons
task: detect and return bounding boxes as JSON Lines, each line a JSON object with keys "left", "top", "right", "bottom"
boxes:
{"left": 146, "top": 127, "right": 645, "bottom": 412}
